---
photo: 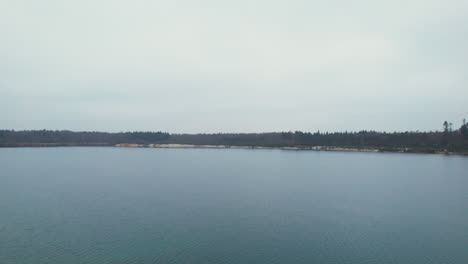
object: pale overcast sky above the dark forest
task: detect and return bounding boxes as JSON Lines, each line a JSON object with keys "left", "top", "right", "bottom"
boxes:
{"left": 0, "top": 0, "right": 468, "bottom": 132}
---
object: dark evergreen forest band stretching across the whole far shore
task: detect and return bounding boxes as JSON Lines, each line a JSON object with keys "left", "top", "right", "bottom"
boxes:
{"left": 0, "top": 121, "right": 468, "bottom": 153}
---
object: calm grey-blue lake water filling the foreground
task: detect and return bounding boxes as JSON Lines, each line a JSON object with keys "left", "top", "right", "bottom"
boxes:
{"left": 0, "top": 147, "right": 468, "bottom": 264}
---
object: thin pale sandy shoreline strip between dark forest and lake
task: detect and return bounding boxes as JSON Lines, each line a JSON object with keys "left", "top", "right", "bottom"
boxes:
{"left": 0, "top": 143, "right": 468, "bottom": 155}
